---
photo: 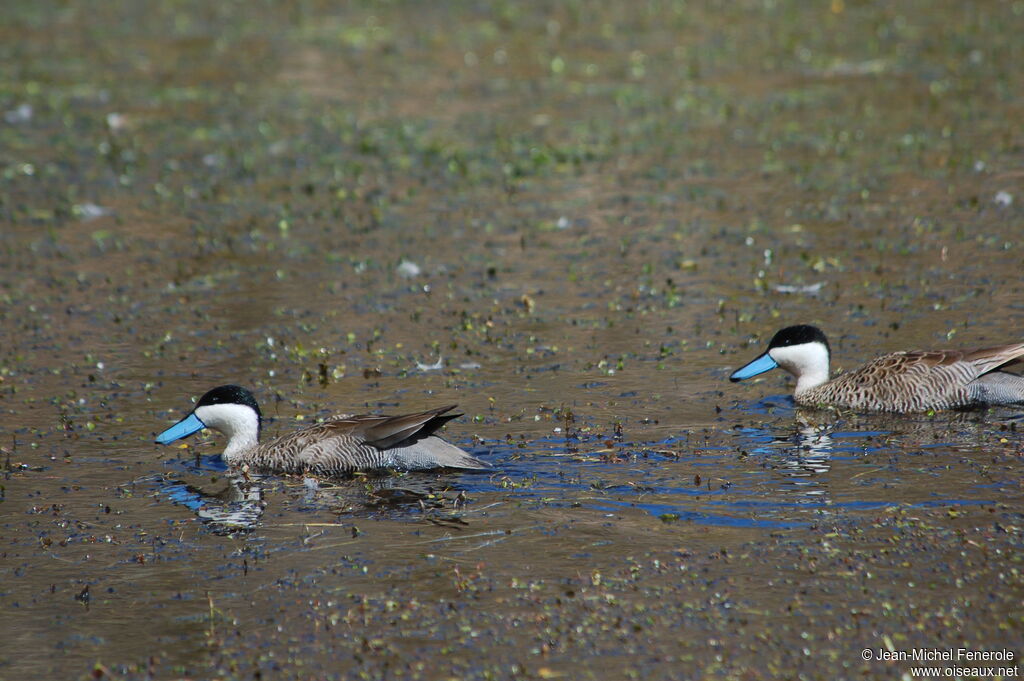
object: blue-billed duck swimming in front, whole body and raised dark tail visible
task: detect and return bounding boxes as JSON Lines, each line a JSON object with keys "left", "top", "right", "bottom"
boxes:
{"left": 157, "top": 385, "right": 492, "bottom": 476}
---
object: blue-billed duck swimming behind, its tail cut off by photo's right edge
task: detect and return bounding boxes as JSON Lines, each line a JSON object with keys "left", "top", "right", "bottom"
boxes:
{"left": 729, "top": 324, "right": 1024, "bottom": 414}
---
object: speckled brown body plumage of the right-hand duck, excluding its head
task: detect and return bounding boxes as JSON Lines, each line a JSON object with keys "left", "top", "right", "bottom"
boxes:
{"left": 794, "top": 343, "right": 1024, "bottom": 413}
